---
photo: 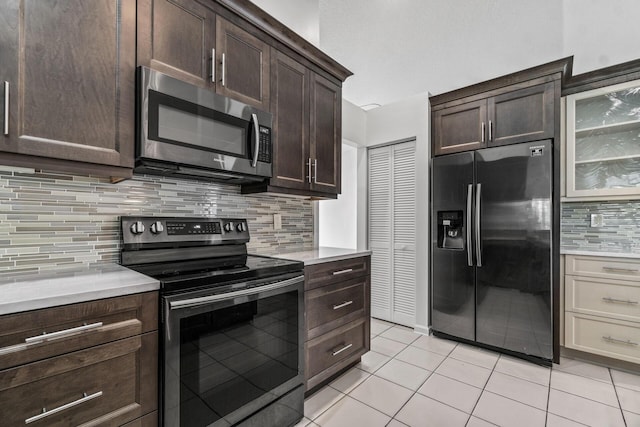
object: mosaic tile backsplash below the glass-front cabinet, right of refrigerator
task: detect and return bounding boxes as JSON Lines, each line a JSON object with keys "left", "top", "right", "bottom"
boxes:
{"left": 560, "top": 200, "right": 640, "bottom": 254}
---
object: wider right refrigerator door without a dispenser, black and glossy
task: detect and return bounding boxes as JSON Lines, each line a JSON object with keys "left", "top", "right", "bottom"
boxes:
{"left": 474, "top": 141, "right": 553, "bottom": 359}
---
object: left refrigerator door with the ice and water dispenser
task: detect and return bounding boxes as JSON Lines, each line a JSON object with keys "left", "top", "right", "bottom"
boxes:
{"left": 431, "top": 152, "right": 475, "bottom": 340}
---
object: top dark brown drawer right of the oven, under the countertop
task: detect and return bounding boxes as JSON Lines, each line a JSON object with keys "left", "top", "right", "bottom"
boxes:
{"left": 304, "top": 256, "right": 370, "bottom": 290}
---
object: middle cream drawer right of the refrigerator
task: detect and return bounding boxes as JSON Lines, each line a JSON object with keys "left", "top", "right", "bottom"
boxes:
{"left": 565, "top": 276, "right": 640, "bottom": 322}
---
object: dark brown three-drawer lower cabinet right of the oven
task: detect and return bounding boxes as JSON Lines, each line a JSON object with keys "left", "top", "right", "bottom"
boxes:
{"left": 304, "top": 255, "right": 371, "bottom": 394}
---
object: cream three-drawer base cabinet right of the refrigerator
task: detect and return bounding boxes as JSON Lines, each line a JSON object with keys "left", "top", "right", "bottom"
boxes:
{"left": 564, "top": 255, "right": 640, "bottom": 363}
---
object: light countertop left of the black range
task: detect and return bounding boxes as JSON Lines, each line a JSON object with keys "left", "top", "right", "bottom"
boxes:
{"left": 0, "top": 264, "right": 160, "bottom": 315}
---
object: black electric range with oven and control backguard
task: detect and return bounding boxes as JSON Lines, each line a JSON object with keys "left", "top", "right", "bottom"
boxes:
{"left": 121, "top": 217, "right": 304, "bottom": 427}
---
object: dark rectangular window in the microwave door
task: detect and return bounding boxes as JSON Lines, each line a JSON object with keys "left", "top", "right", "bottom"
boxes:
{"left": 149, "top": 91, "right": 250, "bottom": 158}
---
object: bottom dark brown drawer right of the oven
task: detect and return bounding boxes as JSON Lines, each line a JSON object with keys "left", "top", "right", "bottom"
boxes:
{"left": 306, "top": 320, "right": 367, "bottom": 378}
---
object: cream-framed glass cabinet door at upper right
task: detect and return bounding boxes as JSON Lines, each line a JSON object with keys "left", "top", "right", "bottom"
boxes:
{"left": 566, "top": 80, "right": 640, "bottom": 199}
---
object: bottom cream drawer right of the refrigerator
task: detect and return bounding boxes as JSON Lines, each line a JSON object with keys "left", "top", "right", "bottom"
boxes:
{"left": 565, "top": 313, "right": 640, "bottom": 363}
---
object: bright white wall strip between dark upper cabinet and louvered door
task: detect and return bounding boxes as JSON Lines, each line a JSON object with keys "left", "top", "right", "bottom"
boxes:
{"left": 318, "top": 144, "right": 358, "bottom": 249}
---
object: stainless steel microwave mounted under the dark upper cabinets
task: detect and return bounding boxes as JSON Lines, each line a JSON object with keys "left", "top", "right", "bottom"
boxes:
{"left": 134, "top": 67, "right": 272, "bottom": 183}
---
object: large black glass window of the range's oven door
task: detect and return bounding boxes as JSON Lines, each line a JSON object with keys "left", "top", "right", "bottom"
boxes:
{"left": 166, "top": 290, "right": 302, "bottom": 427}
